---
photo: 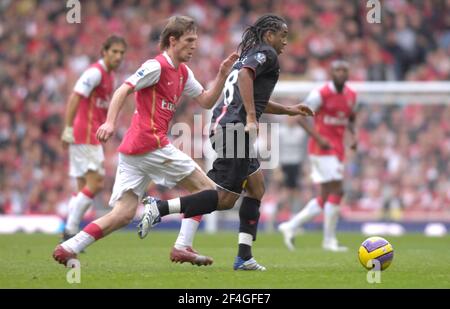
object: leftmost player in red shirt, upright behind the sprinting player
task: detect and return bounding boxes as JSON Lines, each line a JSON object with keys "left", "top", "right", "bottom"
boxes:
{"left": 61, "top": 35, "right": 127, "bottom": 240}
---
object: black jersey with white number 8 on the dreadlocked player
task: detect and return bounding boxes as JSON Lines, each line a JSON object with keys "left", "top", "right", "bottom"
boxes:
{"left": 211, "top": 44, "right": 280, "bottom": 130}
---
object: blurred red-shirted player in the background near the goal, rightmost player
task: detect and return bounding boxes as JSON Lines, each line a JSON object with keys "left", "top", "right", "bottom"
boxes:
{"left": 278, "top": 60, "right": 356, "bottom": 252}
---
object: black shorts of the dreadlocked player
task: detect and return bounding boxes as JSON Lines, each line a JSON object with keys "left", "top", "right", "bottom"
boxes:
{"left": 208, "top": 126, "right": 260, "bottom": 194}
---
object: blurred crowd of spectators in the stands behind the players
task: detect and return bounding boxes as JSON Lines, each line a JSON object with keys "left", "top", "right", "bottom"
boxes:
{"left": 0, "top": 0, "right": 450, "bottom": 221}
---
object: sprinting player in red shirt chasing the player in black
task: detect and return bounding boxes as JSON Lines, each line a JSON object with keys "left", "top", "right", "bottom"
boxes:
{"left": 53, "top": 16, "right": 238, "bottom": 265}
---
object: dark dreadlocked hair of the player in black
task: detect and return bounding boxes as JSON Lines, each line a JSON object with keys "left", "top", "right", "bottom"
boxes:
{"left": 238, "top": 14, "right": 286, "bottom": 60}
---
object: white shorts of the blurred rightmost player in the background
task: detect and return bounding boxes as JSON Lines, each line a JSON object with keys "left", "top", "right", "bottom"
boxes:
{"left": 309, "top": 155, "right": 344, "bottom": 183}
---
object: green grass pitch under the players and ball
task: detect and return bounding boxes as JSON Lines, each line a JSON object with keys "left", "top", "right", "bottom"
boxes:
{"left": 0, "top": 231, "right": 450, "bottom": 288}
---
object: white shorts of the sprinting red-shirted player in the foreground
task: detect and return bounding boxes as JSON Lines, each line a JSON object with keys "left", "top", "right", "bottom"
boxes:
{"left": 109, "top": 144, "right": 197, "bottom": 207}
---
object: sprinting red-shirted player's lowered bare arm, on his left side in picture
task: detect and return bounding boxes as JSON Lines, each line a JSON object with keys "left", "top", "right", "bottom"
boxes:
{"left": 96, "top": 84, "right": 133, "bottom": 142}
